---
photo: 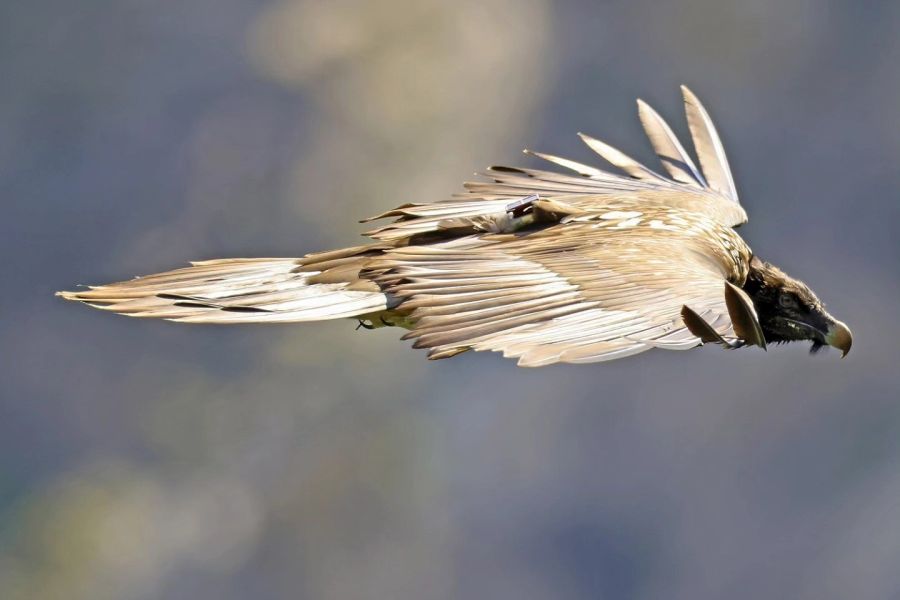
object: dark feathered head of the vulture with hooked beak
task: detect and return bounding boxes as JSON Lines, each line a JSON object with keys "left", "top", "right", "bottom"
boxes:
{"left": 744, "top": 256, "right": 853, "bottom": 358}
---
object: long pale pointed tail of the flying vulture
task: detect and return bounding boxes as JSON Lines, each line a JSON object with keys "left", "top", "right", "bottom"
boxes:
{"left": 57, "top": 258, "right": 388, "bottom": 323}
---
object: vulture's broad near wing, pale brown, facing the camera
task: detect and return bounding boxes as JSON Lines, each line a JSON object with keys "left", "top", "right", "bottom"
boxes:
{"left": 373, "top": 216, "right": 757, "bottom": 366}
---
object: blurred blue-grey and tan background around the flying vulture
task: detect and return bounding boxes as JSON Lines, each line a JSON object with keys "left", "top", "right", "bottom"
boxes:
{"left": 0, "top": 0, "right": 900, "bottom": 600}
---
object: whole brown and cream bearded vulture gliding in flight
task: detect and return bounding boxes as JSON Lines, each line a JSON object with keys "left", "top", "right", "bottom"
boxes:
{"left": 59, "top": 86, "right": 852, "bottom": 367}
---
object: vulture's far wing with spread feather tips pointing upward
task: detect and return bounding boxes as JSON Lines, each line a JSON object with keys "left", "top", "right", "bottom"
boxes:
{"left": 358, "top": 86, "right": 747, "bottom": 240}
